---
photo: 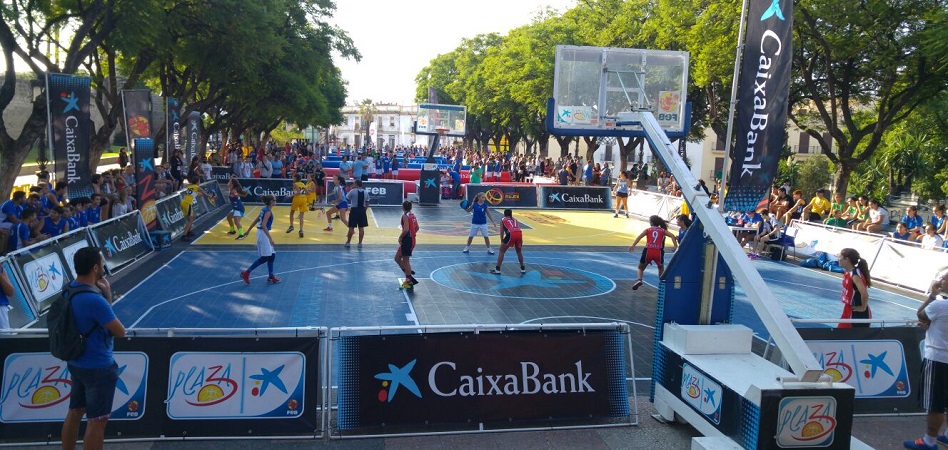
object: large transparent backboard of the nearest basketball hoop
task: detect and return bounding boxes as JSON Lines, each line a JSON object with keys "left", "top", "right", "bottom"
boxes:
{"left": 548, "top": 45, "right": 688, "bottom": 134}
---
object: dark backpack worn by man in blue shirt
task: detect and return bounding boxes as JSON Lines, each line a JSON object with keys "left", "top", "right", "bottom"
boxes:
{"left": 46, "top": 285, "right": 99, "bottom": 361}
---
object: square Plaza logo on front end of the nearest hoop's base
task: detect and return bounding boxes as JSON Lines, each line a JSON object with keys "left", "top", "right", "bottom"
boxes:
{"left": 777, "top": 397, "right": 837, "bottom": 448}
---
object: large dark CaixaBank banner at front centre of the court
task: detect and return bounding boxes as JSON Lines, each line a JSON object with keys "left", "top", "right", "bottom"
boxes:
{"left": 337, "top": 330, "right": 630, "bottom": 433}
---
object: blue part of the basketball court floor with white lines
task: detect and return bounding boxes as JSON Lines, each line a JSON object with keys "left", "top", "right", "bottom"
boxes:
{"left": 115, "top": 245, "right": 919, "bottom": 338}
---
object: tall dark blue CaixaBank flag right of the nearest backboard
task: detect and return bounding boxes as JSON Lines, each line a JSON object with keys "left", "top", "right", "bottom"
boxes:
{"left": 724, "top": 0, "right": 793, "bottom": 211}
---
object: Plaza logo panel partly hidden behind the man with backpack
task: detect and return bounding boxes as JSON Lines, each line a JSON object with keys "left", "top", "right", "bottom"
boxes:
{"left": 0, "top": 352, "right": 148, "bottom": 423}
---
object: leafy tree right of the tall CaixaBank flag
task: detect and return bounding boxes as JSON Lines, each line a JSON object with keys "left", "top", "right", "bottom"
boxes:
{"left": 789, "top": 0, "right": 948, "bottom": 194}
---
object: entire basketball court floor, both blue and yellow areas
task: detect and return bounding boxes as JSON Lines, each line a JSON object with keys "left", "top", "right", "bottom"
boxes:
{"left": 115, "top": 202, "right": 919, "bottom": 384}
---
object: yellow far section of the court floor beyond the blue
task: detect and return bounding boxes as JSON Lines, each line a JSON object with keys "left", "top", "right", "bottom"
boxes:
{"left": 195, "top": 206, "right": 648, "bottom": 247}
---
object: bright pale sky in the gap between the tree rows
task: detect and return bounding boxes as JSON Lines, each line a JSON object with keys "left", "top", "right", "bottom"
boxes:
{"left": 331, "top": 0, "right": 576, "bottom": 105}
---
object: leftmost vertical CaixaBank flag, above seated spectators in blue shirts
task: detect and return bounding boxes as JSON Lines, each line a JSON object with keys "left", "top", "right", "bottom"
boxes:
{"left": 46, "top": 73, "right": 94, "bottom": 200}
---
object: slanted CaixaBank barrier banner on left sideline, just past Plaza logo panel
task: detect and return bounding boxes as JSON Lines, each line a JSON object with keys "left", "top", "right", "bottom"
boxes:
{"left": 89, "top": 211, "right": 152, "bottom": 273}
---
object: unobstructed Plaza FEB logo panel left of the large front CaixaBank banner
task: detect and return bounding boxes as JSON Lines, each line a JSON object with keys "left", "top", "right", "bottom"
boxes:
{"left": 165, "top": 352, "right": 306, "bottom": 420}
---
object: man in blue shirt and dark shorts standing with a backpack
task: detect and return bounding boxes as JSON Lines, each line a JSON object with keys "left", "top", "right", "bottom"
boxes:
{"left": 62, "top": 247, "right": 125, "bottom": 450}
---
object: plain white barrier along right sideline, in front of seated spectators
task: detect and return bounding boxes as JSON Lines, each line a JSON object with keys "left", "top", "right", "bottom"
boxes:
{"left": 792, "top": 221, "right": 948, "bottom": 292}
